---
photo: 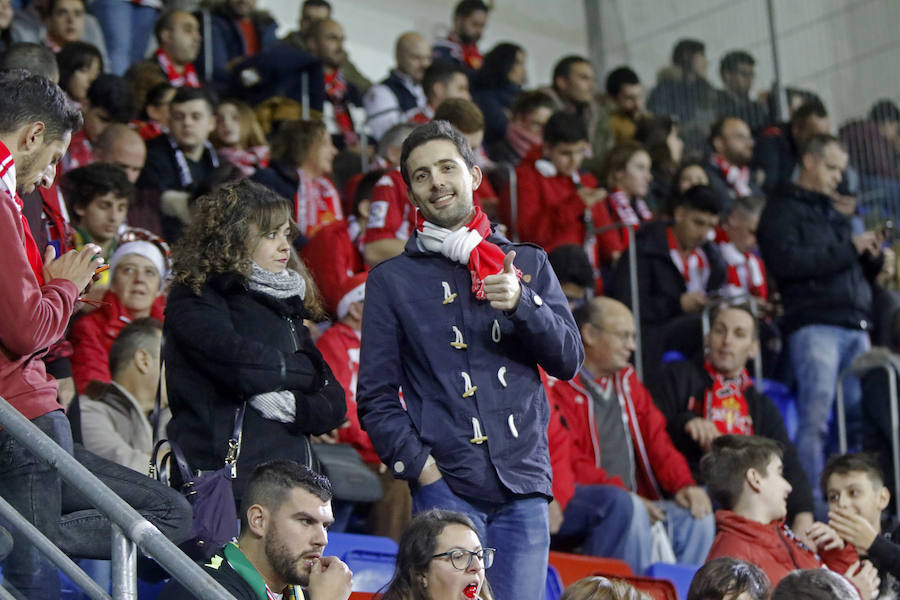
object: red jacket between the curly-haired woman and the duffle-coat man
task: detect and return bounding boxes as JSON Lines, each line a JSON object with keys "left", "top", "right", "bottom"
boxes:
{"left": 316, "top": 323, "right": 381, "bottom": 465}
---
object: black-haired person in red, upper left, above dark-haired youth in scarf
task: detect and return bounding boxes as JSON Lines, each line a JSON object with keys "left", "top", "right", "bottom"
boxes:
{"left": 60, "top": 74, "right": 132, "bottom": 172}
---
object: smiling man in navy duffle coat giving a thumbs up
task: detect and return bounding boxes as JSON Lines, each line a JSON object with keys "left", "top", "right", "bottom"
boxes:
{"left": 357, "top": 121, "right": 584, "bottom": 599}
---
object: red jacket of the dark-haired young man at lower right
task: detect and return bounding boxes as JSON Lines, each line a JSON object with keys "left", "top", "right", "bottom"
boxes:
{"left": 706, "top": 510, "right": 859, "bottom": 588}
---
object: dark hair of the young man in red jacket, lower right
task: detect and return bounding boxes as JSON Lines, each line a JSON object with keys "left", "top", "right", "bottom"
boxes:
{"left": 700, "top": 435, "right": 784, "bottom": 510}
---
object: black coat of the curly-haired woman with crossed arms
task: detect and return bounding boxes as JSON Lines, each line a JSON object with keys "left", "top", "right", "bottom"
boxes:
{"left": 164, "top": 274, "right": 346, "bottom": 498}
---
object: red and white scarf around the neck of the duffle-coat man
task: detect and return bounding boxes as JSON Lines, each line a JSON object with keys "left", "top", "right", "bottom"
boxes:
{"left": 416, "top": 206, "right": 522, "bottom": 300}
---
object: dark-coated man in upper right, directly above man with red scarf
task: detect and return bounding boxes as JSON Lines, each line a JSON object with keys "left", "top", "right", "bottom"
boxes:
{"left": 716, "top": 50, "right": 770, "bottom": 132}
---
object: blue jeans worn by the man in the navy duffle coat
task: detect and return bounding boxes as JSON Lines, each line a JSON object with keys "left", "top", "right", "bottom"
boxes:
{"left": 413, "top": 479, "right": 550, "bottom": 600}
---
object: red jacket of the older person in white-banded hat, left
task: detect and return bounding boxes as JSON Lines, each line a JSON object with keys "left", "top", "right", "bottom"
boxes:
{"left": 69, "top": 291, "right": 166, "bottom": 394}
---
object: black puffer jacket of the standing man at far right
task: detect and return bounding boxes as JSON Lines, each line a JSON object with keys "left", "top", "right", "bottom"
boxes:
{"left": 757, "top": 183, "right": 884, "bottom": 335}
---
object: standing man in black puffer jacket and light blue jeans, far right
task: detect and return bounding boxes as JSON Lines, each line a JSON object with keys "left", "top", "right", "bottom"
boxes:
{"left": 758, "top": 135, "right": 883, "bottom": 502}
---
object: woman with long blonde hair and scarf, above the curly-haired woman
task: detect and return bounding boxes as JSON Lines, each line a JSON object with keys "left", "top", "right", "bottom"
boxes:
{"left": 210, "top": 100, "right": 269, "bottom": 177}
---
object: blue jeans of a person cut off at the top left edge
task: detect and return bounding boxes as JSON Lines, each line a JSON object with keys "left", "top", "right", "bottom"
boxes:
{"left": 90, "top": 0, "right": 158, "bottom": 75}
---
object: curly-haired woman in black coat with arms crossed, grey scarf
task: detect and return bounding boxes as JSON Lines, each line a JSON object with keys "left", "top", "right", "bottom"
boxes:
{"left": 164, "top": 180, "right": 346, "bottom": 500}
